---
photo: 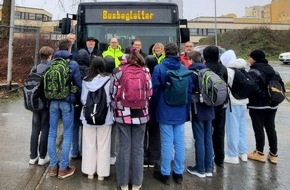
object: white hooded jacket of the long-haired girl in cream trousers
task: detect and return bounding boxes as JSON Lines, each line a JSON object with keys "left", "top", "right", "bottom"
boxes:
{"left": 80, "top": 75, "right": 113, "bottom": 127}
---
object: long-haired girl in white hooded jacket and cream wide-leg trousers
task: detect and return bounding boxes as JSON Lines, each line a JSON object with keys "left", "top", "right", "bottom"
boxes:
{"left": 81, "top": 57, "right": 113, "bottom": 181}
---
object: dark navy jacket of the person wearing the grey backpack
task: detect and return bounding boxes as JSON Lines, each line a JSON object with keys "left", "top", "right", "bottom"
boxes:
{"left": 188, "top": 63, "right": 215, "bottom": 121}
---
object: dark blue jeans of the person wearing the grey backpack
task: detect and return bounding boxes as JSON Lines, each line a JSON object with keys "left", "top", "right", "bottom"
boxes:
{"left": 192, "top": 120, "right": 213, "bottom": 173}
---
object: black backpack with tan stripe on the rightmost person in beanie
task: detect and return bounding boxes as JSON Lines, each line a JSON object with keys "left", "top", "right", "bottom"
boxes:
{"left": 251, "top": 69, "right": 286, "bottom": 105}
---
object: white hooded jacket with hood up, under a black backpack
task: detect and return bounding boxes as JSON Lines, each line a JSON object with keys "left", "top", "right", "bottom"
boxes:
{"left": 220, "top": 50, "right": 249, "bottom": 106}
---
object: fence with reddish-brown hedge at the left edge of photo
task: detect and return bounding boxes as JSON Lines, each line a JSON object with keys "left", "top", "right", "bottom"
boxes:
{"left": 0, "top": 25, "right": 65, "bottom": 88}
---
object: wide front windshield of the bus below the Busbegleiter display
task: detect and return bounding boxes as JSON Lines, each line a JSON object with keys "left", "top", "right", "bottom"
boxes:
{"left": 82, "top": 25, "right": 178, "bottom": 54}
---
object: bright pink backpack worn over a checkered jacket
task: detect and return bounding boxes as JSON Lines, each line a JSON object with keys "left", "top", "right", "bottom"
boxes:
{"left": 116, "top": 63, "right": 152, "bottom": 109}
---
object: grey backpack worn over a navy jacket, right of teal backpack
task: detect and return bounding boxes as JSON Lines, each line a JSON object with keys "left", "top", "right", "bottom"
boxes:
{"left": 198, "top": 68, "right": 228, "bottom": 106}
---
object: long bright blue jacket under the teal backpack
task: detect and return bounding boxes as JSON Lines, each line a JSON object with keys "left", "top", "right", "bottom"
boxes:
{"left": 152, "top": 56, "right": 192, "bottom": 125}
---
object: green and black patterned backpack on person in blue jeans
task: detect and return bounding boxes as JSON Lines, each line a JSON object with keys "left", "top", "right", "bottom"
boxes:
{"left": 44, "top": 58, "right": 71, "bottom": 99}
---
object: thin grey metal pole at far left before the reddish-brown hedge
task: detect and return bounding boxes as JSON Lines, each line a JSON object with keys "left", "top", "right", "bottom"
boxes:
{"left": 7, "top": 0, "right": 15, "bottom": 90}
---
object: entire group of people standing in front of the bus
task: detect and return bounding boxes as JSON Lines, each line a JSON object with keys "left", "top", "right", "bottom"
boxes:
{"left": 29, "top": 34, "right": 284, "bottom": 190}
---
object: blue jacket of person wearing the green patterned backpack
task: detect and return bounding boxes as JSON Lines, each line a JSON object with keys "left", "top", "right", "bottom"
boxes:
{"left": 54, "top": 50, "right": 82, "bottom": 103}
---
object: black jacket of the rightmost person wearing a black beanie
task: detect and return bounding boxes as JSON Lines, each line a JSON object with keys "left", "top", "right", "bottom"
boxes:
{"left": 248, "top": 59, "right": 278, "bottom": 109}
